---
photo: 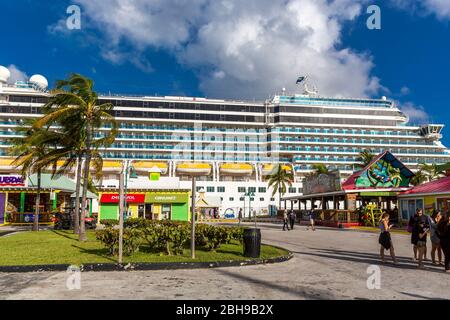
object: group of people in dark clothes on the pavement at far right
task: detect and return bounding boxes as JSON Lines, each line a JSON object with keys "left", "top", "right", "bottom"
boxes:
{"left": 379, "top": 209, "right": 450, "bottom": 273}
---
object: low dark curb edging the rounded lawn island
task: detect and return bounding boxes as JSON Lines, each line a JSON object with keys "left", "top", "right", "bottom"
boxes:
{"left": 0, "top": 246, "right": 294, "bottom": 273}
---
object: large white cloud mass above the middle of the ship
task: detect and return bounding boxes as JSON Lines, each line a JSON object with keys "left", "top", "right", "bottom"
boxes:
{"left": 71, "top": 0, "right": 383, "bottom": 98}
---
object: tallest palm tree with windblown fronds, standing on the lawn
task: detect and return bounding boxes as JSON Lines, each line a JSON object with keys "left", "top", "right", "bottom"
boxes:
{"left": 35, "top": 74, "right": 118, "bottom": 241}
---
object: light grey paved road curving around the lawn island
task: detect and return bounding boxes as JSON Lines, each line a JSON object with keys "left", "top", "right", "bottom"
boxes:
{"left": 0, "top": 224, "right": 450, "bottom": 300}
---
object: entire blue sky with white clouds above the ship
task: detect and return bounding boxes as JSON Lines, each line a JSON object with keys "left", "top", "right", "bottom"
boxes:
{"left": 0, "top": 0, "right": 450, "bottom": 145}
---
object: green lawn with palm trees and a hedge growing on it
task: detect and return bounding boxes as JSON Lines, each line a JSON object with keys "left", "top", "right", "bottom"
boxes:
{"left": 0, "top": 231, "right": 287, "bottom": 266}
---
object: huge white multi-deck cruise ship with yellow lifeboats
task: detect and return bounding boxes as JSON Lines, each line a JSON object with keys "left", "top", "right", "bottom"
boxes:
{"left": 0, "top": 67, "right": 450, "bottom": 214}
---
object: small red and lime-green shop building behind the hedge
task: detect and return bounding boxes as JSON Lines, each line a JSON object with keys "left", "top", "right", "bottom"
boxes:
{"left": 98, "top": 189, "right": 190, "bottom": 222}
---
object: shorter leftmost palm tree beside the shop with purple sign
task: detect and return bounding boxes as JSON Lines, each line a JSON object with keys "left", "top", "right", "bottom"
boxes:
{"left": 8, "top": 120, "right": 59, "bottom": 231}
